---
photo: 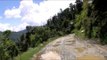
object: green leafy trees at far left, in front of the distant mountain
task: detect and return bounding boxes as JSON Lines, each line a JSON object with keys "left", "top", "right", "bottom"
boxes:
{"left": 0, "top": 30, "right": 19, "bottom": 60}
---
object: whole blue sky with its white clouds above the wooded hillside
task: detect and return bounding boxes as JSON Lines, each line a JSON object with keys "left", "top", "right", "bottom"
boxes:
{"left": 0, "top": 0, "right": 75, "bottom": 31}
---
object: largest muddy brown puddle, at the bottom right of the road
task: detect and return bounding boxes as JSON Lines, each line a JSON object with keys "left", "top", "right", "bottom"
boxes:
{"left": 77, "top": 55, "right": 105, "bottom": 60}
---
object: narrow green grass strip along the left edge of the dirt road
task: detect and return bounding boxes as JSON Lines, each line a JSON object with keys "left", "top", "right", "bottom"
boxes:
{"left": 15, "top": 36, "right": 59, "bottom": 60}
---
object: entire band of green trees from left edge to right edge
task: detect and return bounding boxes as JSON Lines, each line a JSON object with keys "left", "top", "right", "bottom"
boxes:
{"left": 0, "top": 0, "right": 107, "bottom": 60}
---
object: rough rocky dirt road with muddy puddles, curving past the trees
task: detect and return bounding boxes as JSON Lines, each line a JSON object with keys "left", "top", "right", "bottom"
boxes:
{"left": 32, "top": 34, "right": 107, "bottom": 60}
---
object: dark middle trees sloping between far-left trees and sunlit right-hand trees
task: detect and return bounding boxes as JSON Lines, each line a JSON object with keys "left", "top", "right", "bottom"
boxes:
{"left": 18, "top": 0, "right": 77, "bottom": 52}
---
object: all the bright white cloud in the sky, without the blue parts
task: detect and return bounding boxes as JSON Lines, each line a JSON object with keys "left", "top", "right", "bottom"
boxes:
{"left": 1, "top": 0, "right": 75, "bottom": 31}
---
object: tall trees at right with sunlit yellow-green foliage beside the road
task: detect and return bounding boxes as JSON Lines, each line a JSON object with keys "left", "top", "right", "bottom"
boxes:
{"left": 75, "top": 0, "right": 107, "bottom": 44}
